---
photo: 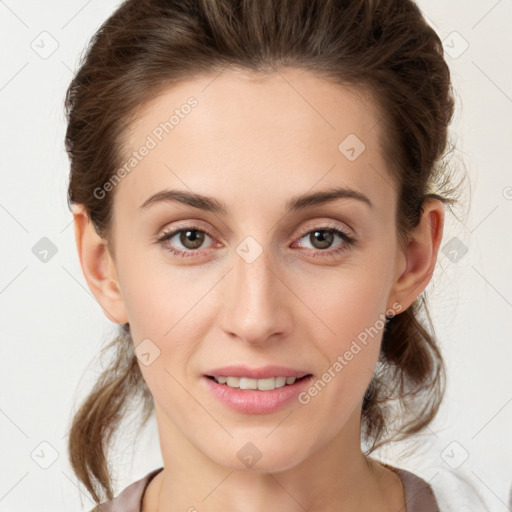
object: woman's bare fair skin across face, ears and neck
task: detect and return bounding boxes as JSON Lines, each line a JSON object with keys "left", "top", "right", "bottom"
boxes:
{"left": 74, "top": 69, "right": 444, "bottom": 512}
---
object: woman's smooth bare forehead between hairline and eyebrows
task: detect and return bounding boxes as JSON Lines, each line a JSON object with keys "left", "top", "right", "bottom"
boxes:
{"left": 116, "top": 69, "right": 394, "bottom": 218}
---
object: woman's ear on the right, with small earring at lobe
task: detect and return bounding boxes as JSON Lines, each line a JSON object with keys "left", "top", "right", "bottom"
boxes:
{"left": 390, "top": 197, "right": 444, "bottom": 311}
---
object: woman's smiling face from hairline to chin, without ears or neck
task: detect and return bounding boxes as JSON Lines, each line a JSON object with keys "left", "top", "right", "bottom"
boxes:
{"left": 96, "top": 70, "right": 407, "bottom": 470}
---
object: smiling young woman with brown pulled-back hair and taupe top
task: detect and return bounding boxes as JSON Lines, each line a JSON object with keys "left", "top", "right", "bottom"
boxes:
{"left": 66, "top": 0, "right": 464, "bottom": 512}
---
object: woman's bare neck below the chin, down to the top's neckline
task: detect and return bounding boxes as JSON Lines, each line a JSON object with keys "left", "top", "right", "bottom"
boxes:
{"left": 143, "top": 404, "right": 405, "bottom": 512}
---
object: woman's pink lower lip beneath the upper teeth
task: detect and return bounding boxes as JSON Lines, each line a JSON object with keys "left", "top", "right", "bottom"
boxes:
{"left": 202, "top": 375, "right": 313, "bottom": 414}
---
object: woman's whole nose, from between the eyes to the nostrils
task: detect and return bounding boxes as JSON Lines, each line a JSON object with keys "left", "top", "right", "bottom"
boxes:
{"left": 221, "top": 241, "right": 293, "bottom": 345}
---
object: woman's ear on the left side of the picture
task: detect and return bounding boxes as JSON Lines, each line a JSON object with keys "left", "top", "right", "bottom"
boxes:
{"left": 72, "top": 205, "right": 128, "bottom": 324}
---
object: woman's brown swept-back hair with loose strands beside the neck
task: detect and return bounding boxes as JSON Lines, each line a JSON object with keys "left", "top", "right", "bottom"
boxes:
{"left": 65, "top": 0, "right": 457, "bottom": 503}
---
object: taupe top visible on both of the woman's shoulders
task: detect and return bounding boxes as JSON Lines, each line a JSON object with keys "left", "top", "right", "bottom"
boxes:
{"left": 90, "top": 464, "right": 440, "bottom": 512}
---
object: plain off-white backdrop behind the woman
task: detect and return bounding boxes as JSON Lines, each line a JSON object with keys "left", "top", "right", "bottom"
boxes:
{"left": 0, "top": 0, "right": 512, "bottom": 512}
